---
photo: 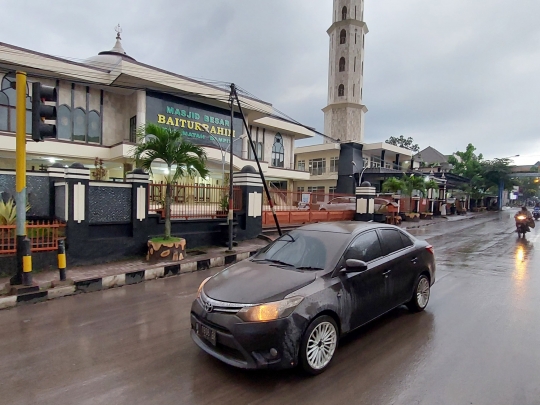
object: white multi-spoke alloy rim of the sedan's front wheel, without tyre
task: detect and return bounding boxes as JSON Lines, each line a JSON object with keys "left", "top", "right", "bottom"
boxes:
{"left": 306, "top": 322, "right": 337, "bottom": 370}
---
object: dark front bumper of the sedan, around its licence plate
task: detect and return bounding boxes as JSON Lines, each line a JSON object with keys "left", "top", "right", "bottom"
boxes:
{"left": 191, "top": 300, "right": 307, "bottom": 369}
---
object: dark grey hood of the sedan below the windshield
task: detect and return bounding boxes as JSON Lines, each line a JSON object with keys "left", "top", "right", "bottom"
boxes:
{"left": 204, "top": 260, "right": 316, "bottom": 304}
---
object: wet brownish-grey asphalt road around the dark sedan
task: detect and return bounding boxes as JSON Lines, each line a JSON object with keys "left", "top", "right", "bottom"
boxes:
{"left": 0, "top": 212, "right": 540, "bottom": 405}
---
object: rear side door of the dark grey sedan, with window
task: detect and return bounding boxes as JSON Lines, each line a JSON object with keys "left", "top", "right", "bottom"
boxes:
{"left": 378, "top": 228, "right": 418, "bottom": 307}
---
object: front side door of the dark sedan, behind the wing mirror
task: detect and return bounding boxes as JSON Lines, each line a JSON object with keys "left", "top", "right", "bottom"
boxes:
{"left": 339, "top": 230, "right": 390, "bottom": 329}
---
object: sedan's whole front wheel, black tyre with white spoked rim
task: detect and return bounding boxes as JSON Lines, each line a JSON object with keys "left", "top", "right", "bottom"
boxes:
{"left": 300, "top": 315, "right": 339, "bottom": 375}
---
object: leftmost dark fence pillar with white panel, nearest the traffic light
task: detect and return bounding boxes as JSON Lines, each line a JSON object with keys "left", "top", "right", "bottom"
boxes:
{"left": 65, "top": 163, "right": 90, "bottom": 254}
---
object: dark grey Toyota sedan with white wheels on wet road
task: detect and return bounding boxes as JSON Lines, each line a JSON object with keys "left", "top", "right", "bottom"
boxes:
{"left": 191, "top": 222, "right": 435, "bottom": 374}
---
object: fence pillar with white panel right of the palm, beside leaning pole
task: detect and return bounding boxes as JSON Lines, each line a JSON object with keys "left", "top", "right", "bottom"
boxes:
{"left": 233, "top": 166, "right": 263, "bottom": 240}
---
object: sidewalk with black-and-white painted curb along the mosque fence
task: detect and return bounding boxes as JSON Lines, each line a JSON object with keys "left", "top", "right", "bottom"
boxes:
{"left": 0, "top": 239, "right": 268, "bottom": 309}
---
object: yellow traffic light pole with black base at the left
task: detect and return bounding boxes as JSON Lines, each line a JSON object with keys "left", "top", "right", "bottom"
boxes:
{"left": 11, "top": 72, "right": 32, "bottom": 286}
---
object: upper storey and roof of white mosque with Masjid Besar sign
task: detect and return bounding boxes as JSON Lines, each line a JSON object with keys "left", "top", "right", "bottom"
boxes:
{"left": 0, "top": 35, "right": 313, "bottom": 189}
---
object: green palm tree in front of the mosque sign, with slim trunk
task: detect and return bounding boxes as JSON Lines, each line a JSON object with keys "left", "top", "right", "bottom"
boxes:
{"left": 133, "top": 124, "right": 208, "bottom": 240}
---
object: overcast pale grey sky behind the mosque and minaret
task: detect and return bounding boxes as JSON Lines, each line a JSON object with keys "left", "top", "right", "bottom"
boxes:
{"left": 0, "top": 0, "right": 540, "bottom": 164}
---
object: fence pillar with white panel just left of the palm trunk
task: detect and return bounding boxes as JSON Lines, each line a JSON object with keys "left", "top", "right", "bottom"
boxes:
{"left": 126, "top": 169, "right": 150, "bottom": 244}
